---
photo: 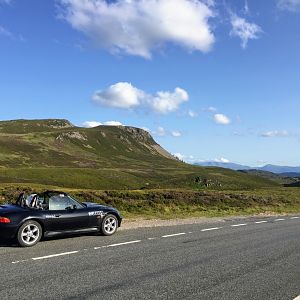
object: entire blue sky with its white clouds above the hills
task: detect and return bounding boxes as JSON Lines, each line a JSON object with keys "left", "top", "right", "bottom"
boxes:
{"left": 0, "top": 0, "right": 300, "bottom": 166}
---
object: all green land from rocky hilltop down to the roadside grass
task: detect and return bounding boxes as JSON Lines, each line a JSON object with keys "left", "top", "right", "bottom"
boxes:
{"left": 0, "top": 120, "right": 300, "bottom": 218}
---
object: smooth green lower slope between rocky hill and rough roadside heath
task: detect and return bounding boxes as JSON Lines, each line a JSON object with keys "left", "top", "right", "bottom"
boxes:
{"left": 0, "top": 163, "right": 280, "bottom": 190}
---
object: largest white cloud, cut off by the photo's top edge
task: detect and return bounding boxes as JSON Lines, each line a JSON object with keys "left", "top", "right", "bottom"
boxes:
{"left": 58, "top": 0, "right": 215, "bottom": 58}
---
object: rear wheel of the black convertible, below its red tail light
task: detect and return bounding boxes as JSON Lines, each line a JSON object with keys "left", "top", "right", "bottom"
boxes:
{"left": 17, "top": 220, "right": 43, "bottom": 247}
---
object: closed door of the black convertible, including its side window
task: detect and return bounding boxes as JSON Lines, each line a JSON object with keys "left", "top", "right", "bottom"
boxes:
{"left": 46, "top": 194, "right": 89, "bottom": 231}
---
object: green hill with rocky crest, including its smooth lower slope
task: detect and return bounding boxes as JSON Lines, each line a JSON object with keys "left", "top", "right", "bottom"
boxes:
{"left": 0, "top": 119, "right": 279, "bottom": 189}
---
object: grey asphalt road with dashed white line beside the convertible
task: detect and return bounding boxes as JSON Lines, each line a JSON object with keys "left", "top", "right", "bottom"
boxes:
{"left": 0, "top": 216, "right": 300, "bottom": 300}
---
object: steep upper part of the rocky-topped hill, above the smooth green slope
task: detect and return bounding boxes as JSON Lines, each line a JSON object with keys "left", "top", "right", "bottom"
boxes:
{"left": 0, "top": 119, "right": 176, "bottom": 168}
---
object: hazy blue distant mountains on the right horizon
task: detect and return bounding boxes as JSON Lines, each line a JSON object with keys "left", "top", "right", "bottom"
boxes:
{"left": 196, "top": 161, "right": 300, "bottom": 177}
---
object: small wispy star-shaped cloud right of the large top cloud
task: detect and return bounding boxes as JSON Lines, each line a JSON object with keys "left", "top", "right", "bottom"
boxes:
{"left": 230, "top": 13, "right": 262, "bottom": 49}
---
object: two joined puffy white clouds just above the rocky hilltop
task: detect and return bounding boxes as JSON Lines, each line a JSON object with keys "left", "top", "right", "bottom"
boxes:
{"left": 92, "top": 82, "right": 189, "bottom": 114}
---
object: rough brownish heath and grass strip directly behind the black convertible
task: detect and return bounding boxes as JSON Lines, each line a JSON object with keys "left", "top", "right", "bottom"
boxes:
{"left": 0, "top": 184, "right": 300, "bottom": 219}
